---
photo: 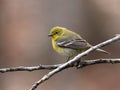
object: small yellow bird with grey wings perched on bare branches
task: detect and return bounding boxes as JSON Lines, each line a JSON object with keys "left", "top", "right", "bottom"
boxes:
{"left": 48, "top": 26, "right": 109, "bottom": 60}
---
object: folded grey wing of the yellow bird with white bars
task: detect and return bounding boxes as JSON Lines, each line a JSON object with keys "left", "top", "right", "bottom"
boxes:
{"left": 57, "top": 38, "right": 91, "bottom": 50}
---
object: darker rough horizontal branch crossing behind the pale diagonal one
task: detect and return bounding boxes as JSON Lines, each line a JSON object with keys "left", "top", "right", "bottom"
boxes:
{"left": 0, "top": 58, "right": 120, "bottom": 73}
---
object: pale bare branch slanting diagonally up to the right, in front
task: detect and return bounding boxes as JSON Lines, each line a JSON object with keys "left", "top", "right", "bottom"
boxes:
{"left": 30, "top": 35, "right": 120, "bottom": 90}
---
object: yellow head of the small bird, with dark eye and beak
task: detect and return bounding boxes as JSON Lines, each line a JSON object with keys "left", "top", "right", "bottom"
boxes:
{"left": 48, "top": 26, "right": 66, "bottom": 40}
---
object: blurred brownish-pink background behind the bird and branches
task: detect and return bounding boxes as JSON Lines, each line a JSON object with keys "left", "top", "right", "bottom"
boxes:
{"left": 0, "top": 0, "right": 120, "bottom": 90}
